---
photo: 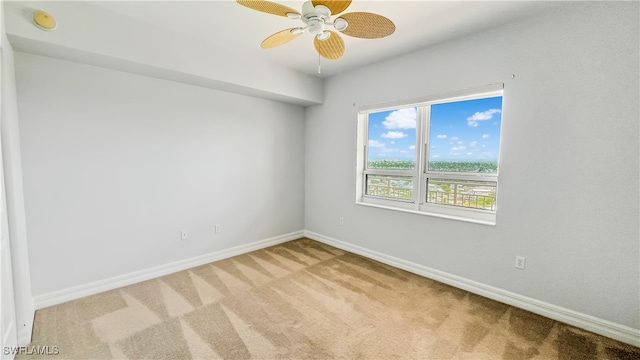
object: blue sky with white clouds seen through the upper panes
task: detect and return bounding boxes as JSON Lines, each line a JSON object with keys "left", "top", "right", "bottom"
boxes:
{"left": 369, "top": 96, "right": 502, "bottom": 161}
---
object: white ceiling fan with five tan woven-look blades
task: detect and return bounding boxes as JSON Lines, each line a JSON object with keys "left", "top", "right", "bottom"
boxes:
{"left": 237, "top": 0, "right": 396, "bottom": 60}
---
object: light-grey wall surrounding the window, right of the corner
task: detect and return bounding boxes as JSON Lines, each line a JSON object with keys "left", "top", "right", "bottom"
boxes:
{"left": 305, "top": 2, "right": 640, "bottom": 329}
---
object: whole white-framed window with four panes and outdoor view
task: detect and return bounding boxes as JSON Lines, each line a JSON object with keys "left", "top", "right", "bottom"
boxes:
{"left": 356, "top": 84, "right": 502, "bottom": 224}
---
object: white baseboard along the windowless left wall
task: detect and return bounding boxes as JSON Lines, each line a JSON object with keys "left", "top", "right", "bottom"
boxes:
{"left": 33, "top": 230, "right": 304, "bottom": 310}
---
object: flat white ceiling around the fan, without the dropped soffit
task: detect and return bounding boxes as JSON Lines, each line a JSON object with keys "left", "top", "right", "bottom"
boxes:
{"left": 91, "top": 0, "right": 557, "bottom": 77}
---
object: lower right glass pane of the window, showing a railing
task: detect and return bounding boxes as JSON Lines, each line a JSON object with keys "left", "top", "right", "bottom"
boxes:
{"left": 426, "top": 179, "right": 497, "bottom": 211}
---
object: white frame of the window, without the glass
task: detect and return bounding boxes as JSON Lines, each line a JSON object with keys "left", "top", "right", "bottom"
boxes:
{"left": 356, "top": 83, "right": 504, "bottom": 225}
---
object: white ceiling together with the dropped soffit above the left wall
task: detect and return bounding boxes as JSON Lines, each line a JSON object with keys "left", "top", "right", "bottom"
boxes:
{"left": 5, "top": 0, "right": 566, "bottom": 105}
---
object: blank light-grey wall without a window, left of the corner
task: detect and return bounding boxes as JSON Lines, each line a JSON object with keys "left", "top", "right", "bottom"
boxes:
{"left": 15, "top": 52, "right": 304, "bottom": 297}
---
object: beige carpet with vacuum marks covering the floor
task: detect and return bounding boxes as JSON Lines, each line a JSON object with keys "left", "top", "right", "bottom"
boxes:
{"left": 16, "top": 239, "right": 640, "bottom": 359}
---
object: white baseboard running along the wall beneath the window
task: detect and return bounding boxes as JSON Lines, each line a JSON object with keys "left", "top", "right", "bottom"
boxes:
{"left": 304, "top": 231, "right": 640, "bottom": 347}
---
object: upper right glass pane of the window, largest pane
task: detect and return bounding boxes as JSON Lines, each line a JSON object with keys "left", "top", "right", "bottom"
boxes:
{"left": 428, "top": 96, "right": 502, "bottom": 173}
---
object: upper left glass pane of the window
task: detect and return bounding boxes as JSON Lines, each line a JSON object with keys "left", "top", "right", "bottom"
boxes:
{"left": 367, "top": 107, "right": 418, "bottom": 170}
